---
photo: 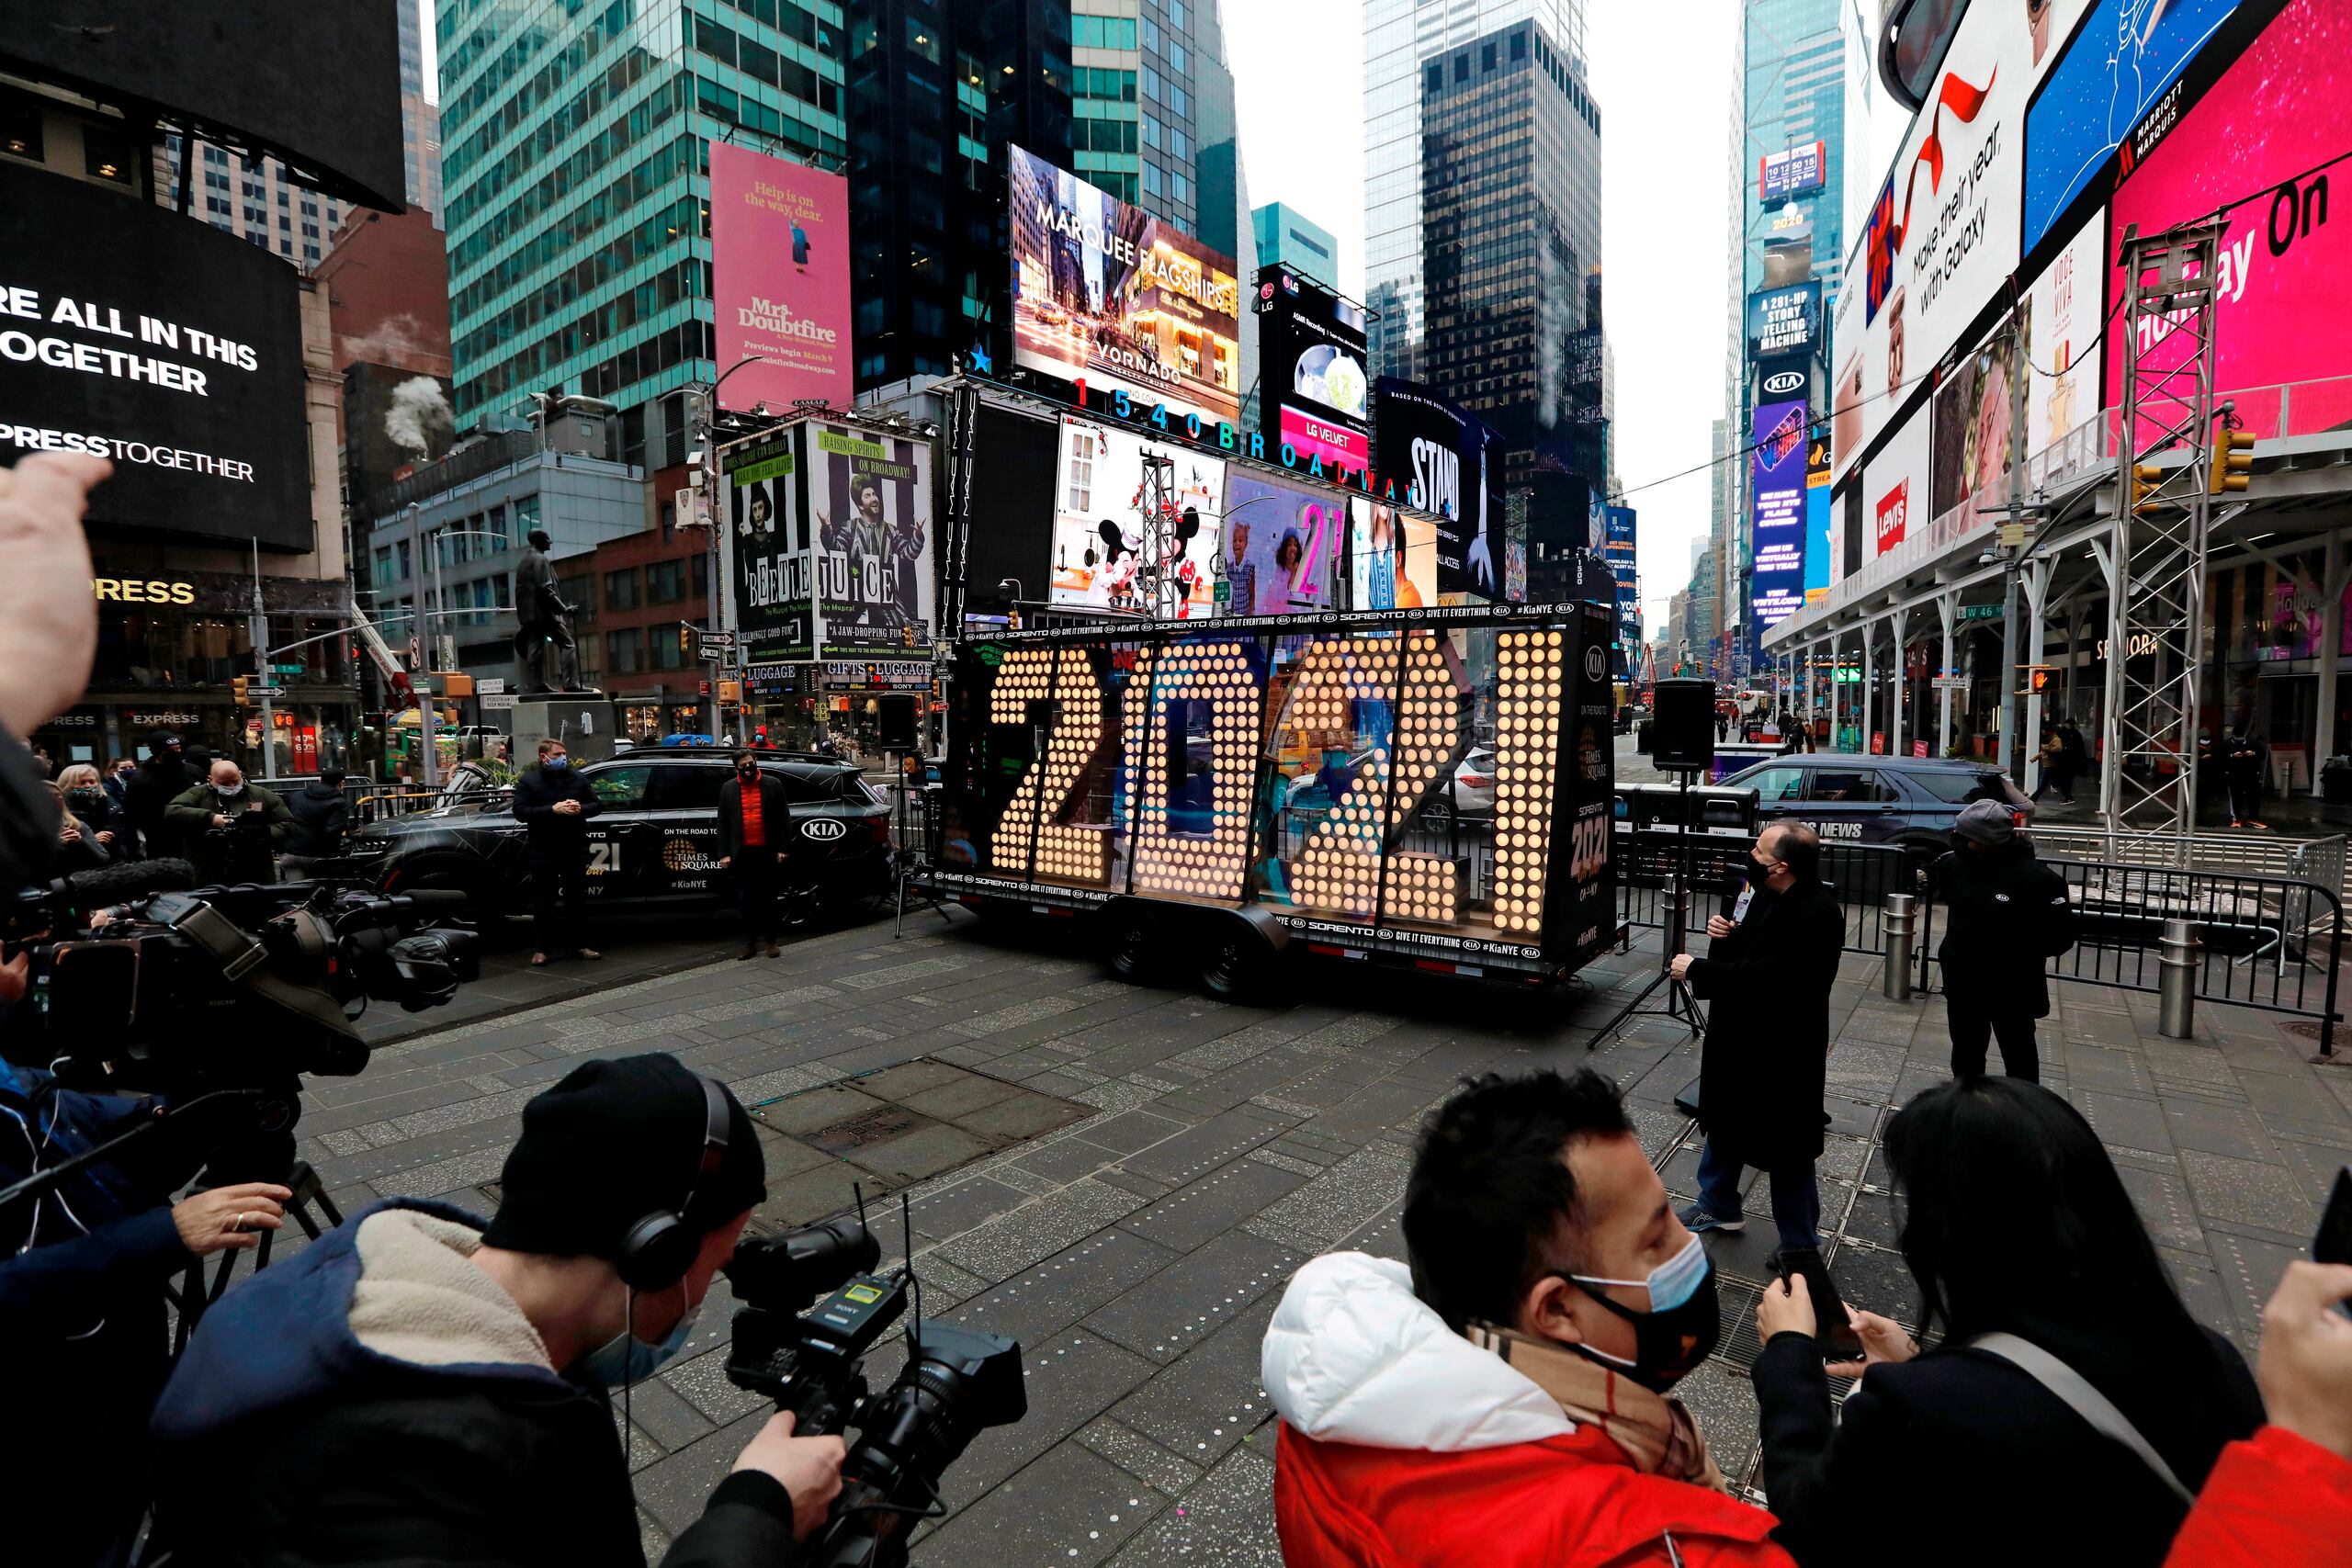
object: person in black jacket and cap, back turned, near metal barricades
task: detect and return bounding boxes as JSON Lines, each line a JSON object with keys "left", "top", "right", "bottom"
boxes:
{"left": 1931, "top": 799, "right": 2075, "bottom": 1084}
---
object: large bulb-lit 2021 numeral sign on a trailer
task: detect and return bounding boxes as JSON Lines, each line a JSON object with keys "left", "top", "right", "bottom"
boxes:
{"left": 941, "top": 606, "right": 1613, "bottom": 968}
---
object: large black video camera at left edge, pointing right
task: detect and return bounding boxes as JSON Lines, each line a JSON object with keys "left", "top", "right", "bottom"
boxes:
{"left": 0, "top": 861, "right": 480, "bottom": 1123}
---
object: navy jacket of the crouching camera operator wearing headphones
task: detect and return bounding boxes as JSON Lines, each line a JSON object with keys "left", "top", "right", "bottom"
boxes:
{"left": 155, "top": 1199, "right": 795, "bottom": 1568}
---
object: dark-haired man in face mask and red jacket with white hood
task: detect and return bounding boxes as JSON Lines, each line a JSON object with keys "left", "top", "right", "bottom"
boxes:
{"left": 1261, "top": 1069, "right": 1790, "bottom": 1568}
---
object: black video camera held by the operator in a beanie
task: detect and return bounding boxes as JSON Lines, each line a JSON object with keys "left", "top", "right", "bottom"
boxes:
{"left": 727, "top": 1218, "right": 1028, "bottom": 1568}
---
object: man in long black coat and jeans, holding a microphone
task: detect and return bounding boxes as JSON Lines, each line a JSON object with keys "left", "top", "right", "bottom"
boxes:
{"left": 1672, "top": 823, "right": 1847, "bottom": 1251}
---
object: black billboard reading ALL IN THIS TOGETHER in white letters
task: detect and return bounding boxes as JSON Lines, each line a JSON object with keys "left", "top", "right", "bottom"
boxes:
{"left": 0, "top": 160, "right": 312, "bottom": 550}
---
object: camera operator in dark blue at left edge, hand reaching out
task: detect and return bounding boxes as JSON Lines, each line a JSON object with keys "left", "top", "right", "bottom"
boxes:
{"left": 0, "top": 954, "right": 287, "bottom": 1563}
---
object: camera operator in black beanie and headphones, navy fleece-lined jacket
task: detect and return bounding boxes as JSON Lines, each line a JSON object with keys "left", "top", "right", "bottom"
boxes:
{"left": 155, "top": 1055, "right": 844, "bottom": 1568}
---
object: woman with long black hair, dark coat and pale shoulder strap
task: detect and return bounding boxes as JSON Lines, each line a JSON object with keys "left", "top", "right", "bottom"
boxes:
{"left": 1755, "top": 1077, "right": 2263, "bottom": 1568}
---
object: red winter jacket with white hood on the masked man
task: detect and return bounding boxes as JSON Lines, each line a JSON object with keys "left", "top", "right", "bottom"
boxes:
{"left": 1263, "top": 1253, "right": 1792, "bottom": 1568}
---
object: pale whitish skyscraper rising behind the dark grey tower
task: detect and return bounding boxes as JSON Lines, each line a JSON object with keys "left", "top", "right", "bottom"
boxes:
{"left": 1364, "top": 0, "right": 1600, "bottom": 381}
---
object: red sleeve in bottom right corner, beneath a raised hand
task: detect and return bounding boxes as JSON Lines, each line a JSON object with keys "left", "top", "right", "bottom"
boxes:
{"left": 2154, "top": 1427, "right": 2352, "bottom": 1568}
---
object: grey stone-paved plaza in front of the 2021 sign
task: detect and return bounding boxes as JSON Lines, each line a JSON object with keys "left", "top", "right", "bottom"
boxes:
{"left": 275, "top": 879, "right": 2352, "bottom": 1568}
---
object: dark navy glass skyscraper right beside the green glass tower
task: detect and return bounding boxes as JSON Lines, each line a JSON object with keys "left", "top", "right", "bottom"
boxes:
{"left": 847, "top": 0, "right": 1072, "bottom": 392}
